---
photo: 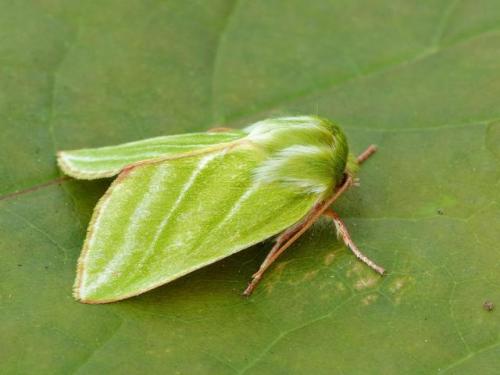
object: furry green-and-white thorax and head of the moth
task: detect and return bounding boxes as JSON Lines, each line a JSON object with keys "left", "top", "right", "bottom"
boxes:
{"left": 245, "top": 116, "right": 355, "bottom": 196}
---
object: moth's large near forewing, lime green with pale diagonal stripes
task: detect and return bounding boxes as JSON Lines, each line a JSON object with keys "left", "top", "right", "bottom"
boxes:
{"left": 75, "top": 143, "right": 318, "bottom": 303}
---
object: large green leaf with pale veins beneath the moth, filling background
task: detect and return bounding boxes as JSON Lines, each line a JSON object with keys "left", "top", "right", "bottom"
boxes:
{"left": 0, "top": 0, "right": 500, "bottom": 374}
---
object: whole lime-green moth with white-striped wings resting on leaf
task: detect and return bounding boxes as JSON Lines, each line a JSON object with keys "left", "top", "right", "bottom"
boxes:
{"left": 58, "top": 116, "right": 384, "bottom": 303}
